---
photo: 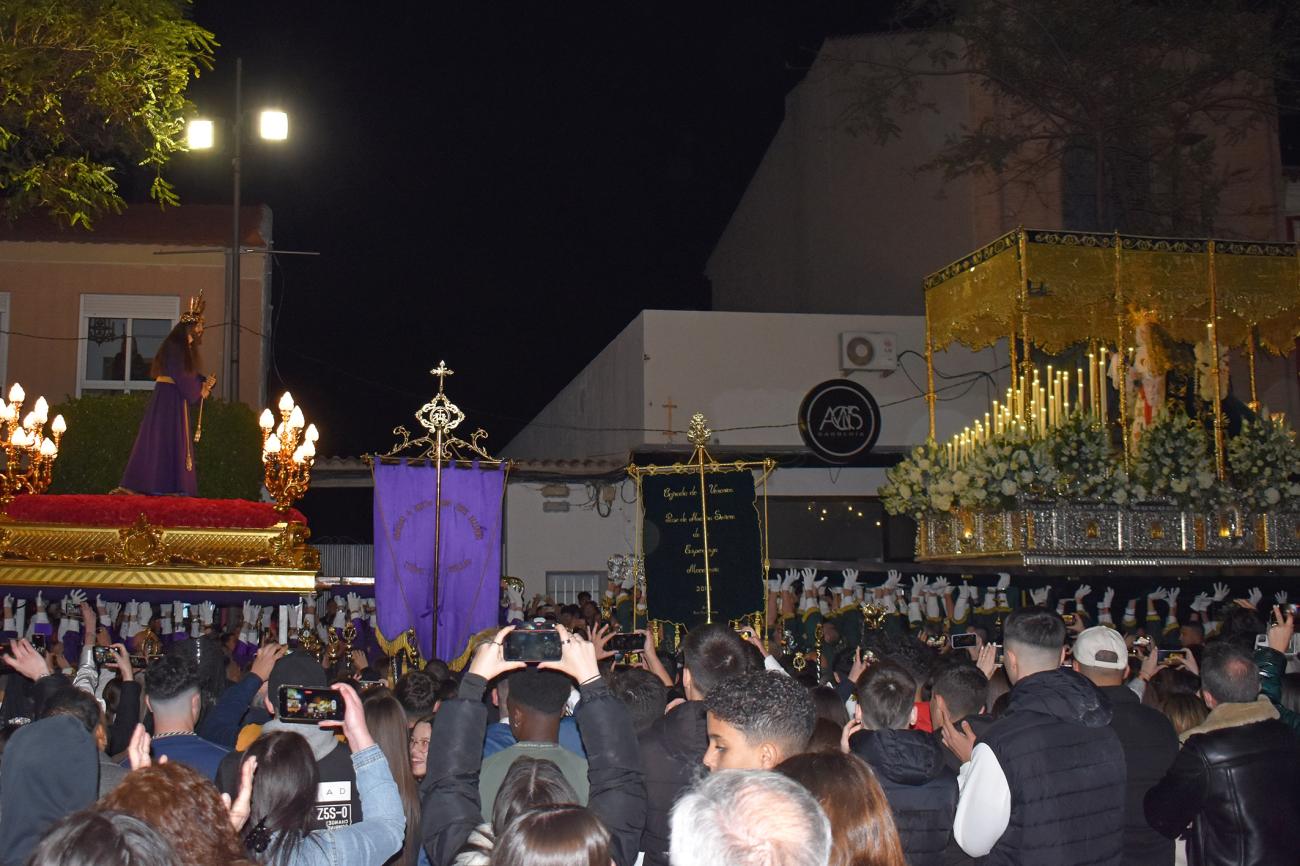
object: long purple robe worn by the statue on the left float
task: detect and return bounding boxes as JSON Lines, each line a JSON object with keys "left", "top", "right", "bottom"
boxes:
{"left": 122, "top": 348, "right": 204, "bottom": 497}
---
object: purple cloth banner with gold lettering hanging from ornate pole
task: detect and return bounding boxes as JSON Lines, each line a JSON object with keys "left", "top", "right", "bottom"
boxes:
{"left": 374, "top": 463, "right": 506, "bottom": 661}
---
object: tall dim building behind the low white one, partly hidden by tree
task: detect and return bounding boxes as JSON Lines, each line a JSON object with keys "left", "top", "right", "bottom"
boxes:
{"left": 705, "top": 35, "right": 1286, "bottom": 315}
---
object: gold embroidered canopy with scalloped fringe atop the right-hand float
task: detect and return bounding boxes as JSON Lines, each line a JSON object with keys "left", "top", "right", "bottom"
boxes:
{"left": 924, "top": 229, "right": 1300, "bottom": 355}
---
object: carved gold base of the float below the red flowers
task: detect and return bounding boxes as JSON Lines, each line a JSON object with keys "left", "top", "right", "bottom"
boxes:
{"left": 0, "top": 515, "right": 320, "bottom": 594}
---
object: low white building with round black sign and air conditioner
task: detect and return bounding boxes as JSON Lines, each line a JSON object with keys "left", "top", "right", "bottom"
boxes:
{"left": 502, "top": 309, "right": 1008, "bottom": 594}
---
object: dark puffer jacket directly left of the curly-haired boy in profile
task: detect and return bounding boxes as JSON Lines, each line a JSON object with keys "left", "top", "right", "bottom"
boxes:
{"left": 641, "top": 701, "right": 709, "bottom": 866}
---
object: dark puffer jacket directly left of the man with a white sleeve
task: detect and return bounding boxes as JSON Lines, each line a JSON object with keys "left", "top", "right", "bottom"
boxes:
{"left": 849, "top": 731, "right": 957, "bottom": 866}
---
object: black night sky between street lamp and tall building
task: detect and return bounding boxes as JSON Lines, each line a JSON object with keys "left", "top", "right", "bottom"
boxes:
{"left": 147, "top": 0, "right": 880, "bottom": 456}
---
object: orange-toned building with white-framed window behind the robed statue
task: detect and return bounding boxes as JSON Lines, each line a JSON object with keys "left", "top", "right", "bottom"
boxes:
{"left": 0, "top": 204, "right": 272, "bottom": 408}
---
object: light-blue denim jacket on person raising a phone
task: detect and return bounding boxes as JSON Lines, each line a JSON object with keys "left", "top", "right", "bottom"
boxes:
{"left": 289, "top": 745, "right": 406, "bottom": 866}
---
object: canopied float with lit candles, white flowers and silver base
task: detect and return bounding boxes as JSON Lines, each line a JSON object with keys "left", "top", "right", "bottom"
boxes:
{"left": 880, "top": 229, "right": 1300, "bottom": 570}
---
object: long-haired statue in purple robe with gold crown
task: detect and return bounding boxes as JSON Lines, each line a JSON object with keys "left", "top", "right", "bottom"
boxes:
{"left": 118, "top": 300, "right": 217, "bottom": 497}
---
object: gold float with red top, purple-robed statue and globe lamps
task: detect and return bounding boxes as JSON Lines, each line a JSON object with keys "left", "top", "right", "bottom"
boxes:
{"left": 0, "top": 296, "right": 320, "bottom": 599}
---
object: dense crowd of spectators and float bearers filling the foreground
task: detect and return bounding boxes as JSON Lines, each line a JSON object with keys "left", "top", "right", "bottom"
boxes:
{"left": 0, "top": 571, "right": 1300, "bottom": 866}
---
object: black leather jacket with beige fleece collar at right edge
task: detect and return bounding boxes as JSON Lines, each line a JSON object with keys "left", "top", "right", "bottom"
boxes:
{"left": 1145, "top": 698, "right": 1300, "bottom": 866}
